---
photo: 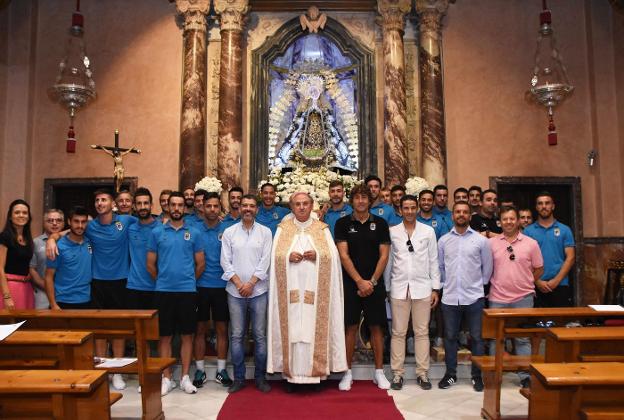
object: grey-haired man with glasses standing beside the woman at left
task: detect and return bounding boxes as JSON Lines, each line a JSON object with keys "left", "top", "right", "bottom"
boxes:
{"left": 30, "top": 209, "right": 65, "bottom": 309}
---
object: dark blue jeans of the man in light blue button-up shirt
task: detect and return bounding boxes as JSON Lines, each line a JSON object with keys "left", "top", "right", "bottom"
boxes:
{"left": 442, "top": 298, "right": 485, "bottom": 378}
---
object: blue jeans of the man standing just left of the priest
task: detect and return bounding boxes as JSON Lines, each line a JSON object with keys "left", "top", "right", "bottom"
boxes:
{"left": 228, "top": 293, "right": 268, "bottom": 381}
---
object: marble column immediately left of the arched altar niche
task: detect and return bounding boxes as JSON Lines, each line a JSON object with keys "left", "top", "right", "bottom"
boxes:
{"left": 214, "top": 0, "right": 249, "bottom": 191}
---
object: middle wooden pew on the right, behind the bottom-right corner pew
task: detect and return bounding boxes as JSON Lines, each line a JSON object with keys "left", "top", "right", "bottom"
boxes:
{"left": 545, "top": 327, "right": 624, "bottom": 363}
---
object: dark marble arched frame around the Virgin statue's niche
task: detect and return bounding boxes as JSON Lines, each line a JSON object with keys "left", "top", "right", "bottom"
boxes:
{"left": 249, "top": 17, "right": 377, "bottom": 188}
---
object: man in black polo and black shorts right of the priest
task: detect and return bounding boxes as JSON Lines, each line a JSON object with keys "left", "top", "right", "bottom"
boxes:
{"left": 334, "top": 184, "right": 390, "bottom": 391}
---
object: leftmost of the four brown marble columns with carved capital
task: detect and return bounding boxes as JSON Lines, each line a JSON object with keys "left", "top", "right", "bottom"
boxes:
{"left": 176, "top": 0, "right": 210, "bottom": 191}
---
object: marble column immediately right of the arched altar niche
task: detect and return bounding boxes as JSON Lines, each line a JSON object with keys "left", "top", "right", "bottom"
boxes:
{"left": 377, "top": 0, "right": 411, "bottom": 185}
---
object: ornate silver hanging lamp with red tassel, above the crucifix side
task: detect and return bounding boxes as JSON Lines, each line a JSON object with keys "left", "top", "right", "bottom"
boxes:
{"left": 48, "top": 0, "right": 96, "bottom": 153}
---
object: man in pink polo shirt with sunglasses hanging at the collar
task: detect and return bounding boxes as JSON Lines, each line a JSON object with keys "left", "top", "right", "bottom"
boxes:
{"left": 488, "top": 207, "right": 544, "bottom": 388}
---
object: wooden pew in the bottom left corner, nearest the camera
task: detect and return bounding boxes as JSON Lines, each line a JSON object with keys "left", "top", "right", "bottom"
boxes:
{"left": 0, "top": 370, "right": 121, "bottom": 420}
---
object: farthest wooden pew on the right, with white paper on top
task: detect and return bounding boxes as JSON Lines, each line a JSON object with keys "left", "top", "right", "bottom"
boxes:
{"left": 480, "top": 307, "right": 623, "bottom": 419}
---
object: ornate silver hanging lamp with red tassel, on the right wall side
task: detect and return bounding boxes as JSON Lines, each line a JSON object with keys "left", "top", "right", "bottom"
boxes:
{"left": 527, "top": 0, "right": 574, "bottom": 146}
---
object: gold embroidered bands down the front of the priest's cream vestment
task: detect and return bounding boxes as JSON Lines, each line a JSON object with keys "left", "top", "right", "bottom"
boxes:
{"left": 275, "top": 219, "right": 332, "bottom": 377}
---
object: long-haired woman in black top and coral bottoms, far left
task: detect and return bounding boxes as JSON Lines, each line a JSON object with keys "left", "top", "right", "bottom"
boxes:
{"left": 0, "top": 200, "right": 34, "bottom": 309}
